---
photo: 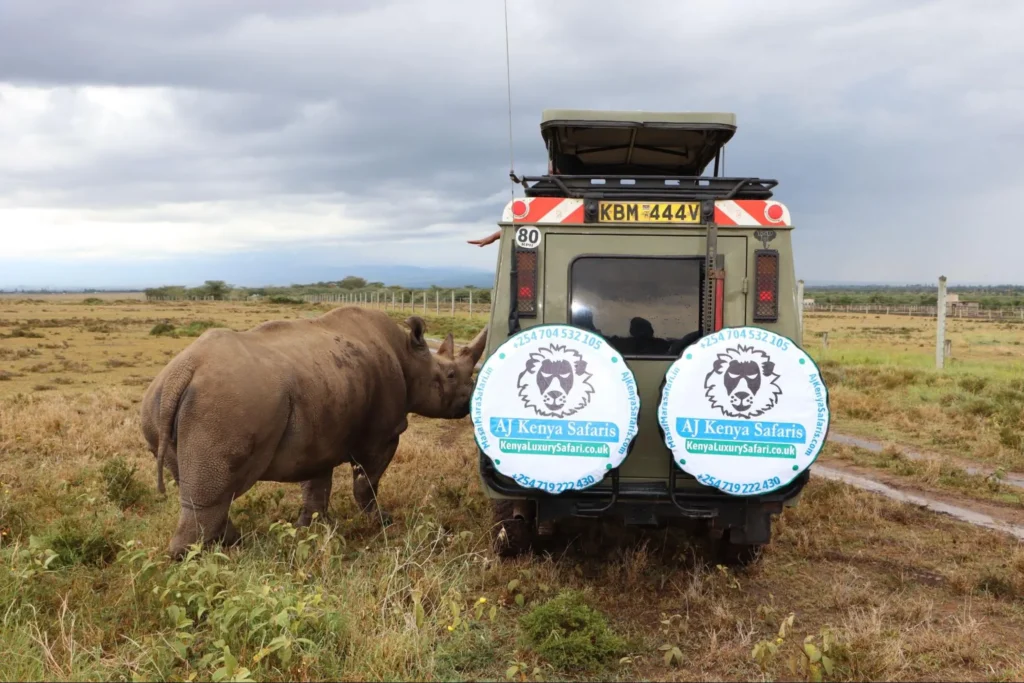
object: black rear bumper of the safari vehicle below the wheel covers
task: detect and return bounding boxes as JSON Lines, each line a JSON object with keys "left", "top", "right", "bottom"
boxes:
{"left": 479, "top": 453, "right": 810, "bottom": 542}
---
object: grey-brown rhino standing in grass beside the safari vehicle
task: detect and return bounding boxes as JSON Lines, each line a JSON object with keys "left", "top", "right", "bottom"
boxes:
{"left": 141, "top": 307, "right": 486, "bottom": 558}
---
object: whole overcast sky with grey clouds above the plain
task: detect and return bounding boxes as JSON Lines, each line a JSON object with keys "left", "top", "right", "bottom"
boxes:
{"left": 0, "top": 0, "right": 1024, "bottom": 285}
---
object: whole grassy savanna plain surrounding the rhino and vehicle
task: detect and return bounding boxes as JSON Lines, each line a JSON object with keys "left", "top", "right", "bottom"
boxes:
{"left": 0, "top": 295, "right": 1024, "bottom": 681}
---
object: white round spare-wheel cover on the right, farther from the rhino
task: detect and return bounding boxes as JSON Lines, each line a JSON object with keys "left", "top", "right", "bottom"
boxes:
{"left": 657, "top": 327, "right": 829, "bottom": 496}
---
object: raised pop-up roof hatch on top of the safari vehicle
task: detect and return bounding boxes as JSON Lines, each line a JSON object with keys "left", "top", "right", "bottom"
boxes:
{"left": 541, "top": 110, "right": 736, "bottom": 176}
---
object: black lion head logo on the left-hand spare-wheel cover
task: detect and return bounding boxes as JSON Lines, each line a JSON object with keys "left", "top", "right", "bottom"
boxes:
{"left": 516, "top": 344, "right": 594, "bottom": 418}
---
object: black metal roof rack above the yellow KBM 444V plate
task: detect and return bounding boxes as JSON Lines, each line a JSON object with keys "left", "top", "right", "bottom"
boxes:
{"left": 513, "top": 174, "right": 778, "bottom": 201}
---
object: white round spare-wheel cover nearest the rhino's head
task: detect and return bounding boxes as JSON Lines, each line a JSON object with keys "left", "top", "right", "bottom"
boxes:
{"left": 470, "top": 325, "right": 640, "bottom": 494}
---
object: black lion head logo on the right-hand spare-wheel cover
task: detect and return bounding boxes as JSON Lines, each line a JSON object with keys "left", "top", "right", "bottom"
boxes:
{"left": 705, "top": 346, "right": 782, "bottom": 419}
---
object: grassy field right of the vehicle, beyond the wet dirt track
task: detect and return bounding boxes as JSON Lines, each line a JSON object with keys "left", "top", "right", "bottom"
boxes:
{"left": 804, "top": 315, "right": 1024, "bottom": 471}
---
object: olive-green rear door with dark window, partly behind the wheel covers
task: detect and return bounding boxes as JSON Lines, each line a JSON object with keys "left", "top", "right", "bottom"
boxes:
{"left": 541, "top": 226, "right": 748, "bottom": 479}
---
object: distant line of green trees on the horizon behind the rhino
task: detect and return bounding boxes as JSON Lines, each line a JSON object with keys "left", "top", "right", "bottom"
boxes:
{"left": 144, "top": 275, "right": 490, "bottom": 303}
